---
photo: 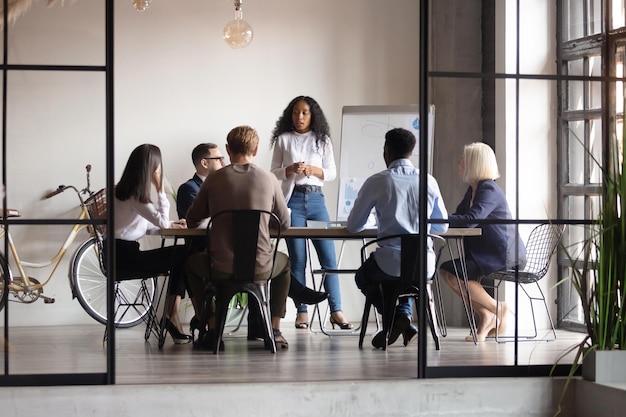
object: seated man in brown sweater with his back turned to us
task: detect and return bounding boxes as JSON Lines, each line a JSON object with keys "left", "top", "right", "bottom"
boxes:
{"left": 187, "top": 126, "right": 291, "bottom": 349}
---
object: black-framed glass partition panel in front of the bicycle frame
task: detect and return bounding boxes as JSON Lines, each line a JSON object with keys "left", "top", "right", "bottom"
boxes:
{"left": 0, "top": 0, "right": 115, "bottom": 386}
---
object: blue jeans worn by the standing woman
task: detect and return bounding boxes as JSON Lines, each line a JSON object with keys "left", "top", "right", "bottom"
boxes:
{"left": 285, "top": 191, "right": 341, "bottom": 313}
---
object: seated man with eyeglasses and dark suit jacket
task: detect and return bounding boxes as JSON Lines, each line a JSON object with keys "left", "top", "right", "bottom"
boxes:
{"left": 176, "top": 143, "right": 224, "bottom": 226}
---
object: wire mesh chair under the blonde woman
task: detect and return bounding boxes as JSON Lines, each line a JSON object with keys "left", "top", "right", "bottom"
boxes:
{"left": 481, "top": 223, "right": 565, "bottom": 341}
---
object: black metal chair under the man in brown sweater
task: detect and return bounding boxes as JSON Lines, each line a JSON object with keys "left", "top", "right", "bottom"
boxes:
{"left": 203, "top": 210, "right": 280, "bottom": 354}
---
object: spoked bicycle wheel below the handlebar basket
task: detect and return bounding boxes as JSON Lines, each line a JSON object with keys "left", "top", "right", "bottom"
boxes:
{"left": 71, "top": 238, "right": 156, "bottom": 327}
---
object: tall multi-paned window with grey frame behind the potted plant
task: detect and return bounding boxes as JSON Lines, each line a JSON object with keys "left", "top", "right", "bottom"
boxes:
{"left": 557, "top": 0, "right": 626, "bottom": 328}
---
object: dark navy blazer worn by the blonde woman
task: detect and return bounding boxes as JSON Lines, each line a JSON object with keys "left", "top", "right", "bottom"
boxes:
{"left": 449, "top": 180, "right": 526, "bottom": 275}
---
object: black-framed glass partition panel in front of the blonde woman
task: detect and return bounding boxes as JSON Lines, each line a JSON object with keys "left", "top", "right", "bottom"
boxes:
{"left": 427, "top": 0, "right": 625, "bottom": 376}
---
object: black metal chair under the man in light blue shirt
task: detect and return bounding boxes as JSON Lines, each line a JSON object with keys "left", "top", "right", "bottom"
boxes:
{"left": 359, "top": 234, "right": 442, "bottom": 350}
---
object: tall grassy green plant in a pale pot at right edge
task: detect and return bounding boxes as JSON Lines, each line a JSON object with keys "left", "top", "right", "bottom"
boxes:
{"left": 555, "top": 129, "right": 626, "bottom": 415}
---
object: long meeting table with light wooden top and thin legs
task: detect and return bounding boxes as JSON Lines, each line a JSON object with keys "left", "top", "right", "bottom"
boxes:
{"left": 160, "top": 226, "right": 482, "bottom": 344}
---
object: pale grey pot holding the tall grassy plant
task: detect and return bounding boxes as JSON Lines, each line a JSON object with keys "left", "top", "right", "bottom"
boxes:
{"left": 583, "top": 350, "right": 626, "bottom": 383}
